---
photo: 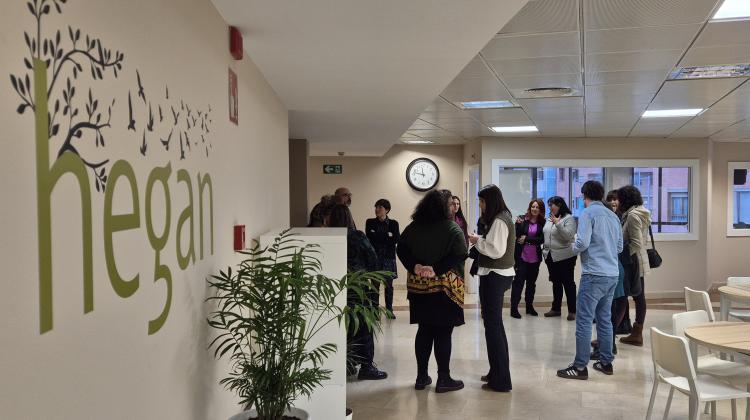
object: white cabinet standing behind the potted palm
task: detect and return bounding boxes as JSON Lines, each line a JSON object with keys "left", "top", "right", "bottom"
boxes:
{"left": 260, "top": 228, "right": 346, "bottom": 420}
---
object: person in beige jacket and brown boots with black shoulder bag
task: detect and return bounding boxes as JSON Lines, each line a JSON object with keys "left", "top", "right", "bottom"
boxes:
{"left": 617, "top": 185, "right": 651, "bottom": 347}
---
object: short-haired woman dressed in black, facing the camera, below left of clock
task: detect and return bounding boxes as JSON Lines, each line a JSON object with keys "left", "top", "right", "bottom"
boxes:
{"left": 365, "top": 198, "right": 400, "bottom": 319}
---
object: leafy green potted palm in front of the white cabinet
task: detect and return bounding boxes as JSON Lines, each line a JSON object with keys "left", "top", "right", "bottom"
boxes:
{"left": 207, "top": 231, "right": 387, "bottom": 420}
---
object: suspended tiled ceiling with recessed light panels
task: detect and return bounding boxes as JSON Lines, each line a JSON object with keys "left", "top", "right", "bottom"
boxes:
{"left": 408, "top": 0, "right": 750, "bottom": 144}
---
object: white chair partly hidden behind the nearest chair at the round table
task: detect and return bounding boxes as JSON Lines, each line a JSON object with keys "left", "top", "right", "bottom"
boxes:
{"left": 672, "top": 310, "right": 750, "bottom": 420}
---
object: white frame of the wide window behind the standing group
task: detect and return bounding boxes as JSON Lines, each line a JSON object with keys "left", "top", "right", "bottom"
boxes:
{"left": 490, "top": 159, "right": 704, "bottom": 242}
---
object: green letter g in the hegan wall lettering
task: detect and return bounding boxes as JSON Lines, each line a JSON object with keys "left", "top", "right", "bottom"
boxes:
{"left": 146, "top": 163, "right": 172, "bottom": 335}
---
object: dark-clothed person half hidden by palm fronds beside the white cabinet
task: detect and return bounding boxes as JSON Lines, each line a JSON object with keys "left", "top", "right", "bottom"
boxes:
{"left": 328, "top": 204, "right": 388, "bottom": 380}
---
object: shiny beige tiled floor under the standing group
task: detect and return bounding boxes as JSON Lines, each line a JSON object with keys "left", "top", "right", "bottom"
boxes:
{"left": 347, "top": 309, "right": 745, "bottom": 420}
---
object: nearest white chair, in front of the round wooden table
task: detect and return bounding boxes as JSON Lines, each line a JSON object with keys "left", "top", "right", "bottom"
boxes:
{"left": 646, "top": 327, "right": 750, "bottom": 420}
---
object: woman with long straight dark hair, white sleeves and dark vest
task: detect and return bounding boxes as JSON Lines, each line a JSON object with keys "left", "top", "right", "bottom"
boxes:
{"left": 469, "top": 185, "right": 516, "bottom": 392}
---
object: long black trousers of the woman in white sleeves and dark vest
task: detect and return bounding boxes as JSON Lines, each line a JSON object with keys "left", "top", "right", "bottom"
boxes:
{"left": 479, "top": 272, "right": 513, "bottom": 391}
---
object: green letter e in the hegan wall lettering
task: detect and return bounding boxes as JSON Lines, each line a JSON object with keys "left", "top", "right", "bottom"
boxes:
{"left": 103, "top": 160, "right": 141, "bottom": 298}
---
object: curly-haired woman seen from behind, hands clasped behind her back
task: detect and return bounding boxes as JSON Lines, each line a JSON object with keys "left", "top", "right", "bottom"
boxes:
{"left": 396, "top": 190, "right": 468, "bottom": 393}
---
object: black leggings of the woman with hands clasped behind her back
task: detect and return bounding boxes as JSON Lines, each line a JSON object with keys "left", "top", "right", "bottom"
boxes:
{"left": 414, "top": 324, "right": 453, "bottom": 378}
